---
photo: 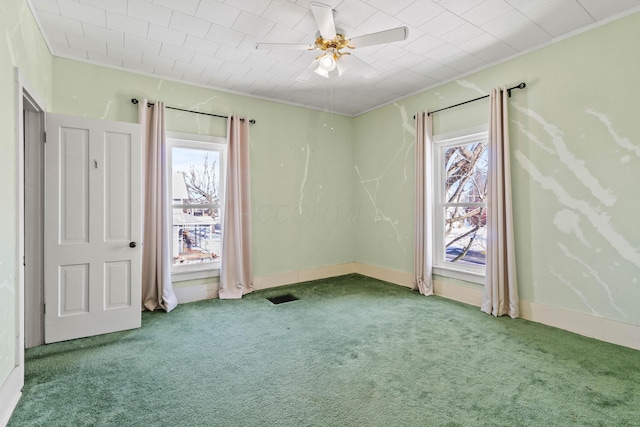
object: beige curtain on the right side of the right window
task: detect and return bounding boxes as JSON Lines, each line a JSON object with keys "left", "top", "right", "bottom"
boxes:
{"left": 481, "top": 88, "right": 520, "bottom": 318}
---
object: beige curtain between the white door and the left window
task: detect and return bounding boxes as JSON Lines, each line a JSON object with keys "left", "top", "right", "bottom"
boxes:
{"left": 138, "top": 99, "right": 178, "bottom": 312}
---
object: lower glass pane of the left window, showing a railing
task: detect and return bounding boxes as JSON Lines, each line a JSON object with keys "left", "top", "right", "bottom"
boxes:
{"left": 171, "top": 209, "right": 221, "bottom": 265}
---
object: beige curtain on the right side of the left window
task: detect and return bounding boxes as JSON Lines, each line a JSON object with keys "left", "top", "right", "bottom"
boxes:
{"left": 220, "top": 115, "right": 253, "bottom": 299}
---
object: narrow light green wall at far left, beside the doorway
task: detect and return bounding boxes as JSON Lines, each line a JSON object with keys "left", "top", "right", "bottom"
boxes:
{"left": 0, "top": 0, "right": 51, "bottom": 385}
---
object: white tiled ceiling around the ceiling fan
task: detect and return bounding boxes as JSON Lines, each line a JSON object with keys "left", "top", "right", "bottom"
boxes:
{"left": 29, "top": 0, "right": 640, "bottom": 116}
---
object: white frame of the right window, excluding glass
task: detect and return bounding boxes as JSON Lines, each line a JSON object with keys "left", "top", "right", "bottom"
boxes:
{"left": 431, "top": 125, "right": 489, "bottom": 284}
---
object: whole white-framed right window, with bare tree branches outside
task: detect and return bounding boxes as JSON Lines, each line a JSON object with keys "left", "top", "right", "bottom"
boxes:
{"left": 433, "top": 130, "right": 488, "bottom": 283}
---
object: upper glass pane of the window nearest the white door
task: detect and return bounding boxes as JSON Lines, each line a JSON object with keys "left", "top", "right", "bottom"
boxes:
{"left": 171, "top": 147, "right": 220, "bottom": 204}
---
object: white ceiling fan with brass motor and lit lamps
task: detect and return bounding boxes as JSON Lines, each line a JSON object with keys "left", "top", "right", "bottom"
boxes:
{"left": 256, "top": 2, "right": 409, "bottom": 81}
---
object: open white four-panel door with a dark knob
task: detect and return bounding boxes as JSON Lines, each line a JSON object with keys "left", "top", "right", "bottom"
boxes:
{"left": 44, "top": 114, "right": 142, "bottom": 343}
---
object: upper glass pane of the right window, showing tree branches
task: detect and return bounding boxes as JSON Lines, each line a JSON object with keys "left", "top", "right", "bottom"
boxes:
{"left": 443, "top": 141, "right": 487, "bottom": 203}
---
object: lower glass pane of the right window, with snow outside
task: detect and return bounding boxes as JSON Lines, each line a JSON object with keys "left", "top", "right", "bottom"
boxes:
{"left": 444, "top": 206, "right": 487, "bottom": 266}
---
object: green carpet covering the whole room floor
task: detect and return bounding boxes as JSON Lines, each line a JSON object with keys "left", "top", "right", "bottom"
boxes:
{"left": 9, "top": 275, "right": 640, "bottom": 427}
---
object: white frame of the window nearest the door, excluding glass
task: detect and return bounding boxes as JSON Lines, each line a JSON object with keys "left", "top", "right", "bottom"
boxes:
{"left": 166, "top": 131, "right": 227, "bottom": 282}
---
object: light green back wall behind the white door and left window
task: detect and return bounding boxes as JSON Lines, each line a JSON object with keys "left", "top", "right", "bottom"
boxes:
{"left": 53, "top": 58, "right": 355, "bottom": 275}
